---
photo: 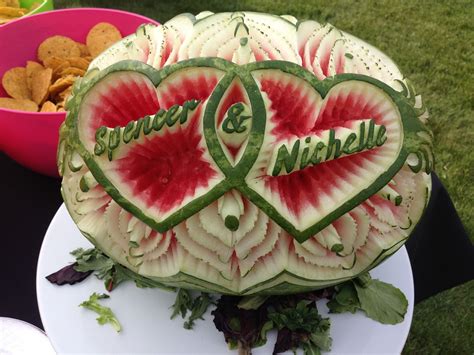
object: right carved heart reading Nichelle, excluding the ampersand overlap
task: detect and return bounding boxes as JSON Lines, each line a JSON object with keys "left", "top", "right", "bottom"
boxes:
{"left": 242, "top": 63, "right": 416, "bottom": 241}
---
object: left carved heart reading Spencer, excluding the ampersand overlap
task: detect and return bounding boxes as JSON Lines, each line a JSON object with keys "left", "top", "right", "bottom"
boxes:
{"left": 71, "top": 62, "right": 233, "bottom": 231}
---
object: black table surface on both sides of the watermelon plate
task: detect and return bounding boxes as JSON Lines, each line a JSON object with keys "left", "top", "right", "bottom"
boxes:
{"left": 0, "top": 153, "right": 474, "bottom": 327}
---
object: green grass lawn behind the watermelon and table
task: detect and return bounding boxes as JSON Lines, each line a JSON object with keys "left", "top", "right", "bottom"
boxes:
{"left": 55, "top": 0, "right": 474, "bottom": 354}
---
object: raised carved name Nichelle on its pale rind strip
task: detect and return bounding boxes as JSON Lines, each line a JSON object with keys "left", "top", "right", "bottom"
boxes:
{"left": 267, "top": 119, "right": 387, "bottom": 176}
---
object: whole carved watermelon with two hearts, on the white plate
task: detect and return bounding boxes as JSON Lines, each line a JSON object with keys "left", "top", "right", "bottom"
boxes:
{"left": 58, "top": 12, "right": 433, "bottom": 295}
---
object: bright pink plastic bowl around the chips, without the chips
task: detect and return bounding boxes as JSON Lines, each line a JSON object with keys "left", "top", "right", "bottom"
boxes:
{"left": 0, "top": 8, "right": 158, "bottom": 176}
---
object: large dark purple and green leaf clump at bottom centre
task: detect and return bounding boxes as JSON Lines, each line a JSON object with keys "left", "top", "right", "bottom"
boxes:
{"left": 212, "top": 292, "right": 331, "bottom": 354}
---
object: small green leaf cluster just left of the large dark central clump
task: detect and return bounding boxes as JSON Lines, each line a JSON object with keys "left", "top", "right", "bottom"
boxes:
{"left": 171, "top": 288, "right": 214, "bottom": 329}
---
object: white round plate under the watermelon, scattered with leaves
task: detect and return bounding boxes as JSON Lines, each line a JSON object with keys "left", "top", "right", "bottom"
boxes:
{"left": 36, "top": 205, "right": 414, "bottom": 354}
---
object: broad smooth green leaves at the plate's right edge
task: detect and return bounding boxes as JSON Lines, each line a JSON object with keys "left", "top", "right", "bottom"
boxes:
{"left": 327, "top": 273, "right": 408, "bottom": 324}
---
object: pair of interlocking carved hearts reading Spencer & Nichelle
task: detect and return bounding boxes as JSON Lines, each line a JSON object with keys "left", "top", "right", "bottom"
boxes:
{"left": 70, "top": 58, "right": 425, "bottom": 242}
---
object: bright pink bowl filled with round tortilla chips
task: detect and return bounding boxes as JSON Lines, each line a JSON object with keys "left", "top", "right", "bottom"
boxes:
{"left": 0, "top": 9, "right": 156, "bottom": 176}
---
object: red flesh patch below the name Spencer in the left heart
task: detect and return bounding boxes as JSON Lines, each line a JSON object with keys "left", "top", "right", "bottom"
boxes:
{"left": 112, "top": 108, "right": 217, "bottom": 213}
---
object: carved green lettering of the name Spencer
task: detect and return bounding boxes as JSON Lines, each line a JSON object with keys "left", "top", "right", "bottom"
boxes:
{"left": 94, "top": 100, "right": 201, "bottom": 161}
